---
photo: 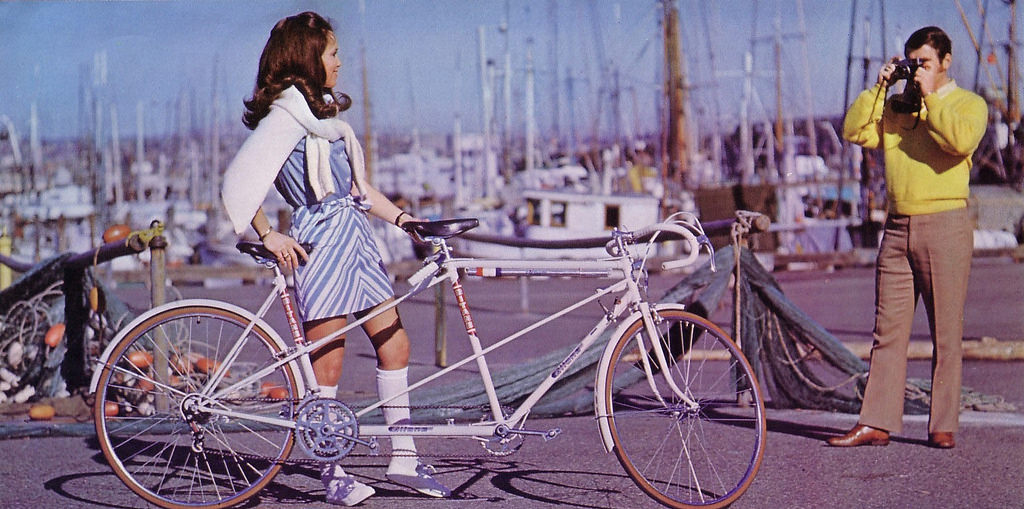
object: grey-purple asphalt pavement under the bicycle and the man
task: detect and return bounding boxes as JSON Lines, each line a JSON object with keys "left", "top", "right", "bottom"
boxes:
{"left": 0, "top": 259, "right": 1024, "bottom": 509}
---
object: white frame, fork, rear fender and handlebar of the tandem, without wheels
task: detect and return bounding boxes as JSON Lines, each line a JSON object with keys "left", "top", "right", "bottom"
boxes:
{"left": 90, "top": 216, "right": 710, "bottom": 451}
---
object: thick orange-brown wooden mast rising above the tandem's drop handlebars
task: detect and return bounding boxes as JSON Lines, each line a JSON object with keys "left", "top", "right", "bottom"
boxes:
{"left": 662, "top": 0, "right": 687, "bottom": 184}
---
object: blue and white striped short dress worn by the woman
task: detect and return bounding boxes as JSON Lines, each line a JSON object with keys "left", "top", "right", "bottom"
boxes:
{"left": 274, "top": 139, "right": 394, "bottom": 322}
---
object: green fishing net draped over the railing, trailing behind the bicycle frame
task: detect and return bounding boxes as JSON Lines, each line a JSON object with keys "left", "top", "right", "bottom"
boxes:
{"left": 372, "top": 246, "right": 1014, "bottom": 420}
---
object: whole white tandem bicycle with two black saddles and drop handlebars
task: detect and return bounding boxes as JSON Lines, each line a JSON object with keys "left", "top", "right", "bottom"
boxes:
{"left": 90, "top": 213, "right": 766, "bottom": 508}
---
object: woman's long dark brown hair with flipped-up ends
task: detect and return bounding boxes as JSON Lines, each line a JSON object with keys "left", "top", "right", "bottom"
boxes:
{"left": 242, "top": 11, "right": 352, "bottom": 129}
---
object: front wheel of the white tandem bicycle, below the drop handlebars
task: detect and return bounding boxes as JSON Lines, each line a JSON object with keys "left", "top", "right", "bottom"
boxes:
{"left": 601, "top": 309, "right": 767, "bottom": 509}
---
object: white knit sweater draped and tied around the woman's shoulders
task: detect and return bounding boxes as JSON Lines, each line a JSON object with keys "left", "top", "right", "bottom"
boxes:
{"left": 220, "top": 86, "right": 366, "bottom": 234}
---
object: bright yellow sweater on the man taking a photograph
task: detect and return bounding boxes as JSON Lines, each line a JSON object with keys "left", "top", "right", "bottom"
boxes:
{"left": 843, "top": 81, "right": 988, "bottom": 215}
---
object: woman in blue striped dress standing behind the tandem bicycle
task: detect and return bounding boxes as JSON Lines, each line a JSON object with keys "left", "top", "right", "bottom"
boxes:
{"left": 221, "top": 12, "right": 450, "bottom": 506}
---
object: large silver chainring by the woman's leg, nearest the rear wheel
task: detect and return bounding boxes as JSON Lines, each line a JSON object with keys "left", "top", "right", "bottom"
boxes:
{"left": 295, "top": 397, "right": 359, "bottom": 461}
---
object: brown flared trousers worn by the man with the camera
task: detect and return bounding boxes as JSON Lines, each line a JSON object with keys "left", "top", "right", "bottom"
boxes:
{"left": 860, "top": 209, "right": 974, "bottom": 432}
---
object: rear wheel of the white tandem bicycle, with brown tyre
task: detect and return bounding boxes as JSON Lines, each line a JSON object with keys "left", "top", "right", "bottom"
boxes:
{"left": 93, "top": 304, "right": 301, "bottom": 508}
